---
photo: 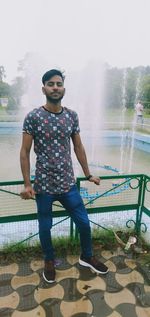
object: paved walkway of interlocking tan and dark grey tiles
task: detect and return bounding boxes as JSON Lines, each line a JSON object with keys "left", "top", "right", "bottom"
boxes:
{"left": 0, "top": 251, "right": 150, "bottom": 317}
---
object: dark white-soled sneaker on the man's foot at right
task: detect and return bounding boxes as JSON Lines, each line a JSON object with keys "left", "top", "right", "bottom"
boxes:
{"left": 79, "top": 255, "right": 108, "bottom": 274}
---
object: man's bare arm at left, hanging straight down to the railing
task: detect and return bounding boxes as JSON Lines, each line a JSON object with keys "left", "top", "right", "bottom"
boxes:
{"left": 20, "top": 133, "right": 35, "bottom": 199}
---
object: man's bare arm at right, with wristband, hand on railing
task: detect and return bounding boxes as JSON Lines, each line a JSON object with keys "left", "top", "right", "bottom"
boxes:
{"left": 72, "top": 133, "right": 100, "bottom": 185}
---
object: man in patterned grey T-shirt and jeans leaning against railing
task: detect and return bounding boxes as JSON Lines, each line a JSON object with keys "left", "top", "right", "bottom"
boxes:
{"left": 20, "top": 69, "right": 108, "bottom": 283}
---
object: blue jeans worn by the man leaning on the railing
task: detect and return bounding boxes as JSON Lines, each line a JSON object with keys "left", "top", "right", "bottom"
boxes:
{"left": 36, "top": 185, "right": 92, "bottom": 260}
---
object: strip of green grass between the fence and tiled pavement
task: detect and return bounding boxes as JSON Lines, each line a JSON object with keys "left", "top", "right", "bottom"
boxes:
{"left": 0, "top": 228, "right": 150, "bottom": 264}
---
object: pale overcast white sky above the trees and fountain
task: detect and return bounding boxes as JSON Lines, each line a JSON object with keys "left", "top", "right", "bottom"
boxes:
{"left": 0, "top": 0, "right": 150, "bottom": 82}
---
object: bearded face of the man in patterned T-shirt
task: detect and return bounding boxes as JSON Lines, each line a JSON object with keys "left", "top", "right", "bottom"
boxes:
{"left": 42, "top": 75, "right": 65, "bottom": 104}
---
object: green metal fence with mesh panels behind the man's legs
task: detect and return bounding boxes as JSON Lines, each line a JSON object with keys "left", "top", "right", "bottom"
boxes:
{"left": 0, "top": 174, "right": 150, "bottom": 248}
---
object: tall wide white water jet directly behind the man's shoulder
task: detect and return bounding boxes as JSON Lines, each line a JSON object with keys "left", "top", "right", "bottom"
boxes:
{"left": 64, "top": 62, "right": 104, "bottom": 175}
